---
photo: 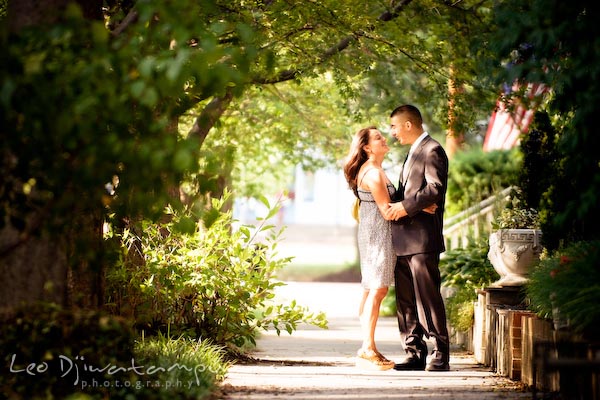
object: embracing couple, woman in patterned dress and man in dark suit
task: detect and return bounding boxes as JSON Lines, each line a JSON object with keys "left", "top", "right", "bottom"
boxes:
{"left": 344, "top": 105, "right": 450, "bottom": 371}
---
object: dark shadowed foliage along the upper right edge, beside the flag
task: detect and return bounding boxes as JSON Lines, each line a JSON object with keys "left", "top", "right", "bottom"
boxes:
{"left": 482, "top": 0, "right": 600, "bottom": 249}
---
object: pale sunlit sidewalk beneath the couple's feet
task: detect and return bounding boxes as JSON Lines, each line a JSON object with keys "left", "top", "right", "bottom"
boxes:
{"left": 223, "top": 282, "right": 531, "bottom": 400}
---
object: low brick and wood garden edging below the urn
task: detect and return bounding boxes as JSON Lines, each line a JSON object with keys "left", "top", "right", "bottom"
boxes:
{"left": 473, "top": 287, "right": 600, "bottom": 400}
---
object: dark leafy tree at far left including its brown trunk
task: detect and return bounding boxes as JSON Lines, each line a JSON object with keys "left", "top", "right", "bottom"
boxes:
{"left": 0, "top": 1, "right": 255, "bottom": 306}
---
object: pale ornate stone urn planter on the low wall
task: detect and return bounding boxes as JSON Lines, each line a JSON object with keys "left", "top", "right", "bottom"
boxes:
{"left": 488, "top": 229, "right": 542, "bottom": 287}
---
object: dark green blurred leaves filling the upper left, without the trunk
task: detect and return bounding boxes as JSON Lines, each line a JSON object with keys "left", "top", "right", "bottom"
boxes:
{"left": 0, "top": 2, "right": 253, "bottom": 258}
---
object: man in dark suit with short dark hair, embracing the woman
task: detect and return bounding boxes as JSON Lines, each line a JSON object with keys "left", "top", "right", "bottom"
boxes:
{"left": 386, "top": 105, "right": 450, "bottom": 371}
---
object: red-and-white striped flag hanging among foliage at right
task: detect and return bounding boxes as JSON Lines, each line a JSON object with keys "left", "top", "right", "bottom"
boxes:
{"left": 483, "top": 83, "right": 547, "bottom": 151}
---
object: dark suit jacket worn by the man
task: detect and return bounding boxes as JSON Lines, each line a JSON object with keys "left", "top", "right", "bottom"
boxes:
{"left": 392, "top": 136, "right": 448, "bottom": 256}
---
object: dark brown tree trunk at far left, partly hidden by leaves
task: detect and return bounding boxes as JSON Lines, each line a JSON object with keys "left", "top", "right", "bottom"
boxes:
{"left": 0, "top": 0, "right": 103, "bottom": 317}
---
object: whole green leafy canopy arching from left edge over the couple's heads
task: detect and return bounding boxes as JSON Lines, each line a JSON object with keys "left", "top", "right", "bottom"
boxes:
{"left": 0, "top": 0, "right": 502, "bottom": 248}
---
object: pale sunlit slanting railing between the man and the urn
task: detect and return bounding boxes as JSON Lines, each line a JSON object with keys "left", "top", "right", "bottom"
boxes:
{"left": 444, "top": 187, "right": 512, "bottom": 250}
